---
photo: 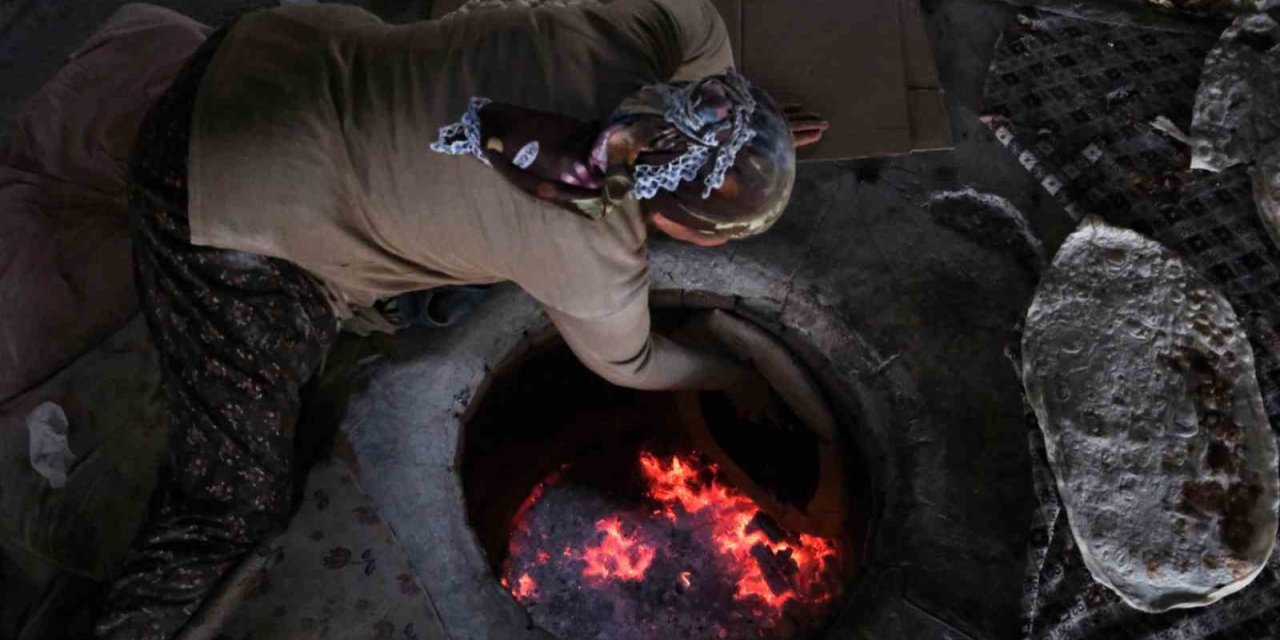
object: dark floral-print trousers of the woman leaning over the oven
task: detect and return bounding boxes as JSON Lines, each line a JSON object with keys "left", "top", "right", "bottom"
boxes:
{"left": 96, "top": 31, "right": 338, "bottom": 640}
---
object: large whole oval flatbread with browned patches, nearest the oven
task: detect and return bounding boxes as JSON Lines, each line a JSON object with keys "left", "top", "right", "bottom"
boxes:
{"left": 1023, "top": 216, "right": 1280, "bottom": 612}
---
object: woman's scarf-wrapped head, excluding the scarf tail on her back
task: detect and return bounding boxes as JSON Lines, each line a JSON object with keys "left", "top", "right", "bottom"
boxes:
{"left": 593, "top": 73, "right": 795, "bottom": 243}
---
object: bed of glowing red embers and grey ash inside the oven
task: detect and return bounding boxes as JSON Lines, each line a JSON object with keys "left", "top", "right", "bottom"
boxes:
{"left": 503, "top": 452, "right": 840, "bottom": 640}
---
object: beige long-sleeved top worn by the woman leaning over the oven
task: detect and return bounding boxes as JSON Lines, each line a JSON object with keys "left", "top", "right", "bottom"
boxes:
{"left": 188, "top": 0, "right": 735, "bottom": 389}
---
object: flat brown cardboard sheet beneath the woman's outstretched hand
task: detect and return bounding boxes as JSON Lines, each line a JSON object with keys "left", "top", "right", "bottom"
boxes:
{"left": 431, "top": 0, "right": 951, "bottom": 161}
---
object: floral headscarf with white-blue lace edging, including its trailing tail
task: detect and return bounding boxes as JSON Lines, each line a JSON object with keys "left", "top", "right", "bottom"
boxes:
{"left": 431, "top": 73, "right": 795, "bottom": 238}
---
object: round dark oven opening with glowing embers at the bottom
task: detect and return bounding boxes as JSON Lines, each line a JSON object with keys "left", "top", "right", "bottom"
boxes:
{"left": 458, "top": 302, "right": 874, "bottom": 640}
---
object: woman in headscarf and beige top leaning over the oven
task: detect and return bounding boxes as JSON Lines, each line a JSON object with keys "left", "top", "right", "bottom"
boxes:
{"left": 96, "top": 0, "right": 824, "bottom": 639}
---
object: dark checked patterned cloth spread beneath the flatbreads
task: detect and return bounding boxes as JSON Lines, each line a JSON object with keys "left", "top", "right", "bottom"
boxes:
{"left": 986, "top": 11, "right": 1280, "bottom": 640}
